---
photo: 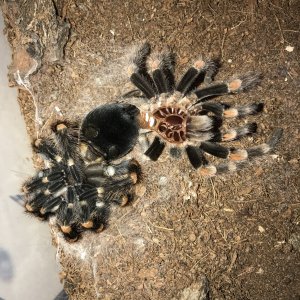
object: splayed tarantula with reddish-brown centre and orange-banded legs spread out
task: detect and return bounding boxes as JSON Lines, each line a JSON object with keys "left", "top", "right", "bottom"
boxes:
{"left": 86, "top": 43, "right": 282, "bottom": 176}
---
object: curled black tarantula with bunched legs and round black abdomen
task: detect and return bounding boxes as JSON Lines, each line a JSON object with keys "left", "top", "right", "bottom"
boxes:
{"left": 23, "top": 104, "right": 141, "bottom": 242}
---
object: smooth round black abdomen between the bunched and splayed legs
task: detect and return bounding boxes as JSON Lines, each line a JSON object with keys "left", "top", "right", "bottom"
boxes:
{"left": 81, "top": 103, "right": 139, "bottom": 160}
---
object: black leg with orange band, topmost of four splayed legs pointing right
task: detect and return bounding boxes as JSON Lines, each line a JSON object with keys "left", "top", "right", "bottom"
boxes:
{"left": 194, "top": 72, "right": 261, "bottom": 104}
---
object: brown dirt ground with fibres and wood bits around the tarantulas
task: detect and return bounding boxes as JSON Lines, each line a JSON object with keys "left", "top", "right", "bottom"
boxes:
{"left": 2, "top": 0, "right": 300, "bottom": 300}
